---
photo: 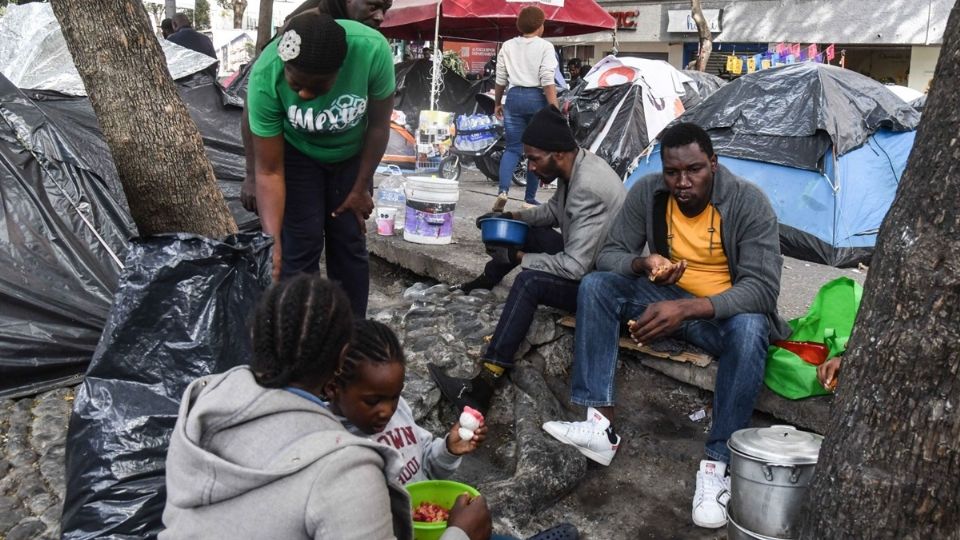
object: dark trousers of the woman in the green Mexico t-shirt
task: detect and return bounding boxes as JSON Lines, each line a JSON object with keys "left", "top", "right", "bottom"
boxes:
{"left": 280, "top": 143, "right": 370, "bottom": 318}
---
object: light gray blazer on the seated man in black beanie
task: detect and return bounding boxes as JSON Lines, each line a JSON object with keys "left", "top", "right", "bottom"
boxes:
{"left": 513, "top": 148, "right": 627, "bottom": 281}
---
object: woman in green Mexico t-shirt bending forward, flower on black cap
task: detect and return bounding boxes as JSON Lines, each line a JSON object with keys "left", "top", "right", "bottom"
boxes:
{"left": 247, "top": 12, "right": 395, "bottom": 317}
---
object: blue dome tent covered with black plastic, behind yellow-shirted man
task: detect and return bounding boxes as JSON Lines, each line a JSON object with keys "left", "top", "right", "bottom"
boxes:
{"left": 627, "top": 63, "right": 920, "bottom": 266}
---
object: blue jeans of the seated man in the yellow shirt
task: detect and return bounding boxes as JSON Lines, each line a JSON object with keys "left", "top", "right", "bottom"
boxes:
{"left": 570, "top": 272, "right": 770, "bottom": 462}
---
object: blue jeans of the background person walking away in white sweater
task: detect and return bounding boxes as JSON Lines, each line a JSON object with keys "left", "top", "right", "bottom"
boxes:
{"left": 500, "top": 86, "right": 547, "bottom": 202}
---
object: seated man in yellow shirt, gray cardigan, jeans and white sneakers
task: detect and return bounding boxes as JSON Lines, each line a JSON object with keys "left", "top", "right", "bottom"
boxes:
{"left": 543, "top": 123, "right": 790, "bottom": 528}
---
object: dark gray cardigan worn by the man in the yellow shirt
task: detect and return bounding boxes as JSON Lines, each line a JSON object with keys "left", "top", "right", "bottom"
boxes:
{"left": 597, "top": 165, "right": 790, "bottom": 340}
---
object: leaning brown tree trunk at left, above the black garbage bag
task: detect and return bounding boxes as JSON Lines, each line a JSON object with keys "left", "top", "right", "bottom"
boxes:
{"left": 53, "top": 0, "right": 237, "bottom": 238}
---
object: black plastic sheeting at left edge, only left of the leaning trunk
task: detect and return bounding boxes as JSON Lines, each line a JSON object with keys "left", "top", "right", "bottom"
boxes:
{"left": 0, "top": 76, "right": 136, "bottom": 397}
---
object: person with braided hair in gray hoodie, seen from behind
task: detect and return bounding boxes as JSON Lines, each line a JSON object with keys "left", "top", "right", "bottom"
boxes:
{"left": 160, "top": 274, "right": 490, "bottom": 540}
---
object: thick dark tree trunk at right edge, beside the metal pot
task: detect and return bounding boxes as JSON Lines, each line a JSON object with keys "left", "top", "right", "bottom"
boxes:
{"left": 801, "top": 6, "right": 960, "bottom": 540}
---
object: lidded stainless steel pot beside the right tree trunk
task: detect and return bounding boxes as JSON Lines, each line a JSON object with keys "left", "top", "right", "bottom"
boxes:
{"left": 727, "top": 426, "right": 823, "bottom": 538}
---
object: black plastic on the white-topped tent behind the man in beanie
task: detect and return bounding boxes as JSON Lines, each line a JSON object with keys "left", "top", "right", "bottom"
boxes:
{"left": 560, "top": 84, "right": 650, "bottom": 176}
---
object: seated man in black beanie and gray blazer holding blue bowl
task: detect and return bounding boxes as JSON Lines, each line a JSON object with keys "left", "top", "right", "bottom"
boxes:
{"left": 429, "top": 106, "right": 626, "bottom": 413}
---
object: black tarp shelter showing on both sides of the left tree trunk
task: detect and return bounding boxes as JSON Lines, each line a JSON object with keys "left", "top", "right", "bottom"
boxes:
{"left": 0, "top": 70, "right": 259, "bottom": 397}
